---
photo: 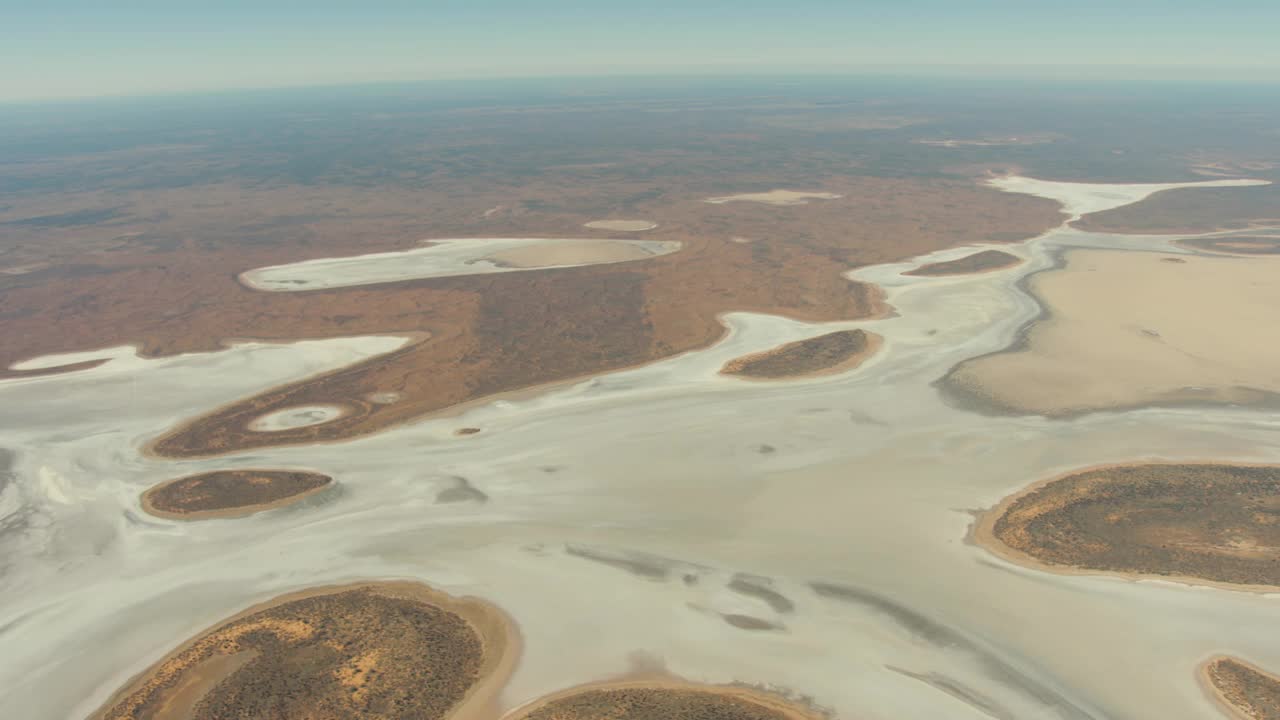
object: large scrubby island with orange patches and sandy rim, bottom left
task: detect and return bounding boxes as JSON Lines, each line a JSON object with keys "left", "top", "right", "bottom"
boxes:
{"left": 93, "top": 582, "right": 518, "bottom": 720}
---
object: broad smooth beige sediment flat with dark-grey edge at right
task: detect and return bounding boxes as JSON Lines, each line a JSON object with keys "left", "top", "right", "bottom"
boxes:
{"left": 945, "top": 250, "right": 1280, "bottom": 416}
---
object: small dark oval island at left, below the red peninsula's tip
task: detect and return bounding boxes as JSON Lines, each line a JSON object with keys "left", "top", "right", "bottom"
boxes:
{"left": 142, "top": 470, "right": 333, "bottom": 520}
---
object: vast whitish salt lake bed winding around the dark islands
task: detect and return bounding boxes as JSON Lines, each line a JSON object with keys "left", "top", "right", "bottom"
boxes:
{"left": 0, "top": 175, "right": 1280, "bottom": 720}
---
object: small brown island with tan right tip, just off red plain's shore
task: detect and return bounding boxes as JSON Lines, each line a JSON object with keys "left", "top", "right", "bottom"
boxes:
{"left": 721, "top": 331, "right": 882, "bottom": 379}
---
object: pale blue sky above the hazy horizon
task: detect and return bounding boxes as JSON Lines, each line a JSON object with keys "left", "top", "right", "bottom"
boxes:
{"left": 0, "top": 0, "right": 1280, "bottom": 100}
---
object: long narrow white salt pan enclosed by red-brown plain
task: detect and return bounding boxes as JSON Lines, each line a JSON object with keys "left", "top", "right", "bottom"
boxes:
{"left": 241, "top": 237, "right": 681, "bottom": 292}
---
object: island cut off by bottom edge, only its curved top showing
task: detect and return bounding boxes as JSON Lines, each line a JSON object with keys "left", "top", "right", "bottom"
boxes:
{"left": 506, "top": 680, "right": 820, "bottom": 720}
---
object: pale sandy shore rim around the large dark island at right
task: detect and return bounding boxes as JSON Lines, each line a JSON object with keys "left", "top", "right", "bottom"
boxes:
{"left": 965, "top": 459, "right": 1280, "bottom": 594}
